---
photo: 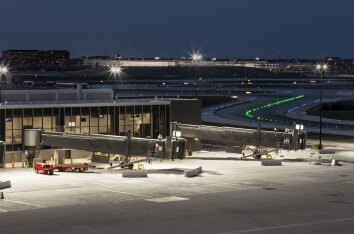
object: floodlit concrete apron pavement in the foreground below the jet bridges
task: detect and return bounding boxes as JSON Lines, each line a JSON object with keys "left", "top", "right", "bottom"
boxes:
{"left": 0, "top": 152, "right": 354, "bottom": 234}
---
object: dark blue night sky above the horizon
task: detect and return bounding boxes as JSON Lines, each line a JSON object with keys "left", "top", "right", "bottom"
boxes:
{"left": 0, "top": 0, "right": 354, "bottom": 58}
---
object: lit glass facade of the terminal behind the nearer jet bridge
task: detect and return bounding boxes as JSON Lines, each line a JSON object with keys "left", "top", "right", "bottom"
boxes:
{"left": 0, "top": 105, "right": 170, "bottom": 151}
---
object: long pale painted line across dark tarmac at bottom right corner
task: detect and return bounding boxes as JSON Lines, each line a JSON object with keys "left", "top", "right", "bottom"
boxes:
{"left": 223, "top": 217, "right": 354, "bottom": 234}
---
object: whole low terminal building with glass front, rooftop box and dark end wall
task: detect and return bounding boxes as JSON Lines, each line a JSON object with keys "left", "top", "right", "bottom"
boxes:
{"left": 0, "top": 85, "right": 201, "bottom": 152}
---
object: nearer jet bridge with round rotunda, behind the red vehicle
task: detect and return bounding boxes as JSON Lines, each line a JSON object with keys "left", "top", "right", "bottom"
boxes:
{"left": 24, "top": 129, "right": 186, "bottom": 165}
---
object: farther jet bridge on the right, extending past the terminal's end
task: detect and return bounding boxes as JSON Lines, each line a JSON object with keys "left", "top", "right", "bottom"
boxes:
{"left": 171, "top": 122, "right": 307, "bottom": 153}
